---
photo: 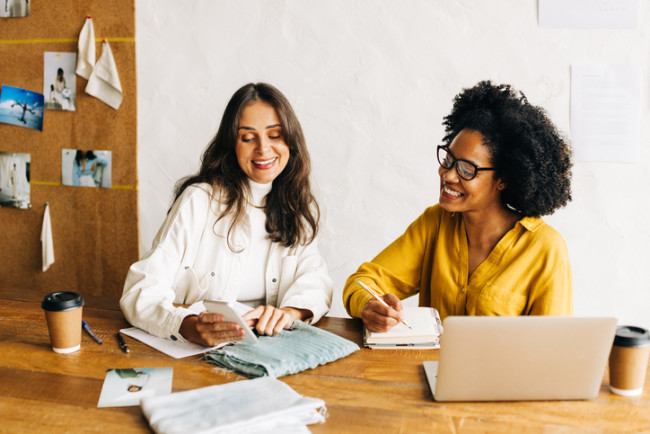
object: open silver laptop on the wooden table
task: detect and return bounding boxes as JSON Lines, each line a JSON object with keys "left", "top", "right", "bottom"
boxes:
{"left": 424, "top": 316, "right": 616, "bottom": 401}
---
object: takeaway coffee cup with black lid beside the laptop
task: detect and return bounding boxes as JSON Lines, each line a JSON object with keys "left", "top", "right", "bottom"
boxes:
{"left": 609, "top": 326, "right": 650, "bottom": 396}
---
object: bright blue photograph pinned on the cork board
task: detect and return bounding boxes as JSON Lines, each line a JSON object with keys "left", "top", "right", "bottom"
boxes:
{"left": 0, "top": 85, "right": 44, "bottom": 131}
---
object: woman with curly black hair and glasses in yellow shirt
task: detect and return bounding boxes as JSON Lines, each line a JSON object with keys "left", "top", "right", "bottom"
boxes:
{"left": 343, "top": 81, "right": 573, "bottom": 331}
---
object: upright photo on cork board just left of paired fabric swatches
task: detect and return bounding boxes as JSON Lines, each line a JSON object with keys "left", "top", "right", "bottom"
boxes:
{"left": 43, "top": 52, "right": 77, "bottom": 111}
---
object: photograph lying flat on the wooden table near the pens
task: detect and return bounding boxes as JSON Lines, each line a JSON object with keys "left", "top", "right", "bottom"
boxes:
{"left": 97, "top": 368, "right": 173, "bottom": 407}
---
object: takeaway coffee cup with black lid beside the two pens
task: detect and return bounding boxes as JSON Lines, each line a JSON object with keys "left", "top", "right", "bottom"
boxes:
{"left": 41, "top": 291, "right": 84, "bottom": 353}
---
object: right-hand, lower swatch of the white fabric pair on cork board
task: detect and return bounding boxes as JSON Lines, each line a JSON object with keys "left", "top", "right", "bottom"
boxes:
{"left": 86, "top": 40, "right": 122, "bottom": 110}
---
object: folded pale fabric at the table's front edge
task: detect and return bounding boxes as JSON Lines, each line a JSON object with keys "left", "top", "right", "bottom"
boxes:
{"left": 140, "top": 377, "right": 326, "bottom": 434}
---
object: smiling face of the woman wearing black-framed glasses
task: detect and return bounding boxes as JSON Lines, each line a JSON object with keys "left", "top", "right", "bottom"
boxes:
{"left": 438, "top": 129, "right": 505, "bottom": 217}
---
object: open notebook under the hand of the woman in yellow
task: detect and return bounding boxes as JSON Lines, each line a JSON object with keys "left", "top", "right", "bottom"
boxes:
{"left": 364, "top": 307, "right": 442, "bottom": 349}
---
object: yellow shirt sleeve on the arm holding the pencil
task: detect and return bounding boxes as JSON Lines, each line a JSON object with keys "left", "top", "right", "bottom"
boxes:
{"left": 343, "top": 207, "right": 437, "bottom": 317}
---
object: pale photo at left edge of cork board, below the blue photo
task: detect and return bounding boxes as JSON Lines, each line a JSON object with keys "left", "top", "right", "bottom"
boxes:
{"left": 0, "top": 152, "right": 31, "bottom": 209}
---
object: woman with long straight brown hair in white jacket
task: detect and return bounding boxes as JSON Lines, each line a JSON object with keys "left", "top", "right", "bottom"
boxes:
{"left": 120, "top": 83, "right": 332, "bottom": 346}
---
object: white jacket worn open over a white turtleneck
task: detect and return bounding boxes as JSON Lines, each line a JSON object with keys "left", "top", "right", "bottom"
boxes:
{"left": 120, "top": 183, "right": 333, "bottom": 341}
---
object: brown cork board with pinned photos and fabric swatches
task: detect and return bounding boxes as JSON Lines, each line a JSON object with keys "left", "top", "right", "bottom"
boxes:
{"left": 0, "top": 0, "right": 139, "bottom": 297}
